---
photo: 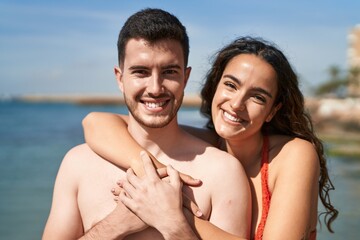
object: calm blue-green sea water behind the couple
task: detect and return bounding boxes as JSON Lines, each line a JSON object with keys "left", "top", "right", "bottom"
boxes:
{"left": 0, "top": 102, "right": 360, "bottom": 240}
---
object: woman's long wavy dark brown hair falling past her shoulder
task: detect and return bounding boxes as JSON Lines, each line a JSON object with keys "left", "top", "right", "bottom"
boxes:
{"left": 201, "top": 37, "right": 338, "bottom": 233}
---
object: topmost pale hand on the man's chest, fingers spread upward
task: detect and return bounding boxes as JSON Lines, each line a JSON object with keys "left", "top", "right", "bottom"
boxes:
{"left": 118, "top": 152, "right": 202, "bottom": 231}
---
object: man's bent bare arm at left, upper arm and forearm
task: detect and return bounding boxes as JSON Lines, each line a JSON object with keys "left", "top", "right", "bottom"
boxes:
{"left": 43, "top": 147, "right": 147, "bottom": 240}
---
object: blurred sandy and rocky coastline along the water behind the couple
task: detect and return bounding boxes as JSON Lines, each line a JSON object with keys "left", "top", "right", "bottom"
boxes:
{"left": 5, "top": 94, "right": 360, "bottom": 158}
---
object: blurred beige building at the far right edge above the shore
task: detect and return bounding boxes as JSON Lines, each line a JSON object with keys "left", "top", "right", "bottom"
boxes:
{"left": 348, "top": 24, "right": 360, "bottom": 97}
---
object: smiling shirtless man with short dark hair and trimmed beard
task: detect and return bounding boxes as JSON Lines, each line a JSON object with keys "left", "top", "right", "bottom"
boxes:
{"left": 43, "top": 9, "right": 250, "bottom": 239}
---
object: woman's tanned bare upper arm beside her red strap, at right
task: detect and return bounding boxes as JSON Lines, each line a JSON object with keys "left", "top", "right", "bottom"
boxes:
{"left": 263, "top": 139, "right": 320, "bottom": 240}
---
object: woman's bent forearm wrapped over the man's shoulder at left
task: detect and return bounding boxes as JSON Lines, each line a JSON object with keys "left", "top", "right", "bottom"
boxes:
{"left": 82, "top": 112, "right": 164, "bottom": 176}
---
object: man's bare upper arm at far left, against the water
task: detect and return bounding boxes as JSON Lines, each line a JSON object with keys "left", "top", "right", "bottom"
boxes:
{"left": 42, "top": 147, "right": 83, "bottom": 240}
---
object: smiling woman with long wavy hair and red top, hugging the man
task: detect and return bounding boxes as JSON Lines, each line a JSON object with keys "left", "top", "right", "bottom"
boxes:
{"left": 84, "top": 37, "right": 338, "bottom": 239}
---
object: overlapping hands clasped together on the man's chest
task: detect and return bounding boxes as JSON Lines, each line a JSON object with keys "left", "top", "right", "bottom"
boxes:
{"left": 111, "top": 152, "right": 203, "bottom": 231}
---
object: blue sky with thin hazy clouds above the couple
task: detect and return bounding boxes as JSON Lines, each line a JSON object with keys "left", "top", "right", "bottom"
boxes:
{"left": 0, "top": 0, "right": 360, "bottom": 97}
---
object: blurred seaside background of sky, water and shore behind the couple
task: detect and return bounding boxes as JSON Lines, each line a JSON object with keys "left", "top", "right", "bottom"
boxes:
{"left": 0, "top": 0, "right": 360, "bottom": 239}
